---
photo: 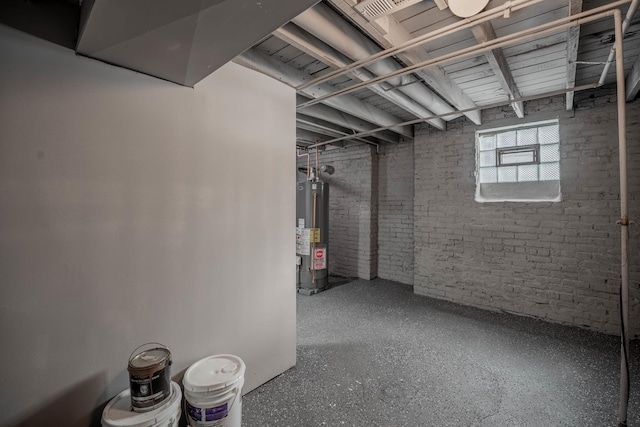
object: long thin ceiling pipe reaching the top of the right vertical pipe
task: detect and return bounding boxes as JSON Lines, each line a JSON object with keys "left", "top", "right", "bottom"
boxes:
{"left": 298, "top": 4, "right": 629, "bottom": 112}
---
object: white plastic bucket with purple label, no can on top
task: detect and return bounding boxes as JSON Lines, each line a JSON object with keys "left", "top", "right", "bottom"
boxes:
{"left": 182, "top": 354, "right": 246, "bottom": 427}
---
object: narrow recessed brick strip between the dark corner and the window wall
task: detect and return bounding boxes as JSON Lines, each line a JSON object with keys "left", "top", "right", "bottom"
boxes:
{"left": 378, "top": 142, "right": 413, "bottom": 285}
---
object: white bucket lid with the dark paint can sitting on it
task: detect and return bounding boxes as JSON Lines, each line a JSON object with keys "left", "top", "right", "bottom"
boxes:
{"left": 102, "top": 381, "right": 182, "bottom": 427}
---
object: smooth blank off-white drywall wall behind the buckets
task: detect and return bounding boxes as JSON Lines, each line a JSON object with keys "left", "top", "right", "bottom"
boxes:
{"left": 0, "top": 26, "right": 295, "bottom": 425}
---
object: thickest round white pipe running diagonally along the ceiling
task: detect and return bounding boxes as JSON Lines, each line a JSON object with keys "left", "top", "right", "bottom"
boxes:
{"left": 292, "top": 3, "right": 455, "bottom": 120}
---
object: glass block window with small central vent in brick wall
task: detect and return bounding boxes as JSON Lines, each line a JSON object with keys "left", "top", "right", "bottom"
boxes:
{"left": 476, "top": 121, "right": 560, "bottom": 184}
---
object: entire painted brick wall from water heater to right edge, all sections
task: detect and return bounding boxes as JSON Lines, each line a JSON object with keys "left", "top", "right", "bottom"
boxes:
{"left": 299, "top": 87, "right": 640, "bottom": 337}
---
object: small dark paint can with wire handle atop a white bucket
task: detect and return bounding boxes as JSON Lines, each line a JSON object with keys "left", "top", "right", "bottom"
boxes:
{"left": 127, "top": 343, "right": 171, "bottom": 412}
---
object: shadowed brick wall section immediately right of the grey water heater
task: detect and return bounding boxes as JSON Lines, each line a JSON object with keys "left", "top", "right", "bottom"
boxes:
{"left": 298, "top": 145, "right": 378, "bottom": 279}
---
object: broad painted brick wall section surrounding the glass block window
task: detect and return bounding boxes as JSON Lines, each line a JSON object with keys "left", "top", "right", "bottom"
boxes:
{"left": 414, "top": 89, "right": 640, "bottom": 336}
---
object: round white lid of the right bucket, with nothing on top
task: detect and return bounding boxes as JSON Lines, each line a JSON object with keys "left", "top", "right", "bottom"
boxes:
{"left": 182, "top": 354, "right": 246, "bottom": 393}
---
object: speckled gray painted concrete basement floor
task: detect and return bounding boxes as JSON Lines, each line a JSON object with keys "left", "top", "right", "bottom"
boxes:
{"left": 243, "top": 279, "right": 640, "bottom": 427}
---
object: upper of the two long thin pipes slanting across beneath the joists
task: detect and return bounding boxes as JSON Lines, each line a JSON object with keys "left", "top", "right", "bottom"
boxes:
{"left": 296, "top": 0, "right": 544, "bottom": 90}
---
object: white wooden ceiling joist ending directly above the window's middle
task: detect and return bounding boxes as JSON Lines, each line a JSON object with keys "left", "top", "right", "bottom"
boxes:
{"left": 471, "top": 22, "right": 524, "bottom": 118}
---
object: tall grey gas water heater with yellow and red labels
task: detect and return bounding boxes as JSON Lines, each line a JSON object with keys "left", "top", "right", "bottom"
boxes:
{"left": 296, "top": 167, "right": 333, "bottom": 295}
